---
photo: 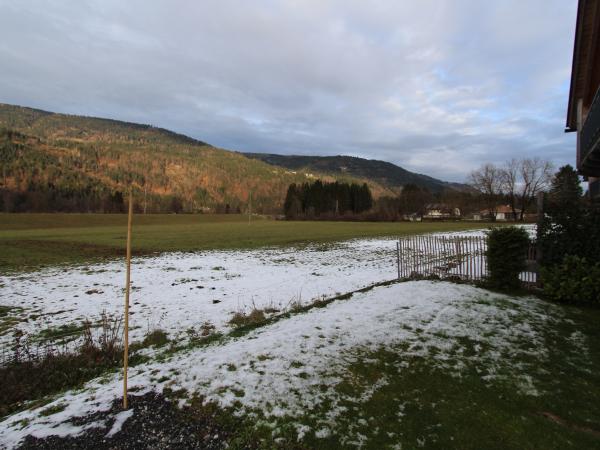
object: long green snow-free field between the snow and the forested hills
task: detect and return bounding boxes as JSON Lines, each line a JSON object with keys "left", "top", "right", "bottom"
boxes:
{"left": 0, "top": 214, "right": 490, "bottom": 271}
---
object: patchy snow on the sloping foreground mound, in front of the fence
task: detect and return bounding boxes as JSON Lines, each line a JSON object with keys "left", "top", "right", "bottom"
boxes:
{"left": 0, "top": 281, "right": 585, "bottom": 447}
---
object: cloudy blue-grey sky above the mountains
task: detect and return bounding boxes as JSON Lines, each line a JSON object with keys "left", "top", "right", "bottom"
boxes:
{"left": 0, "top": 0, "right": 577, "bottom": 182}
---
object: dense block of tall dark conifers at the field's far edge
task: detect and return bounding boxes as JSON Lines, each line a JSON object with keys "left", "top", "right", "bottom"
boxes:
{"left": 283, "top": 180, "right": 373, "bottom": 219}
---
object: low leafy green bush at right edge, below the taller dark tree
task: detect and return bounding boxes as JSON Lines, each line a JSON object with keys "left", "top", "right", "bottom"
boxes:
{"left": 541, "top": 255, "right": 600, "bottom": 303}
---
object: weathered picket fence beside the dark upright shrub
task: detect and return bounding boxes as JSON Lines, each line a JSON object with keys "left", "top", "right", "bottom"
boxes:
{"left": 396, "top": 235, "right": 538, "bottom": 286}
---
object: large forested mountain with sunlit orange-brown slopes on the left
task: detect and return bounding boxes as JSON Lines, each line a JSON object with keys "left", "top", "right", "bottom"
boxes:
{"left": 0, "top": 104, "right": 464, "bottom": 213}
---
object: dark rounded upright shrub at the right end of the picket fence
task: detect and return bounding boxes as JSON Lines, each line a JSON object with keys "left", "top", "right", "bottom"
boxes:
{"left": 486, "top": 227, "right": 529, "bottom": 289}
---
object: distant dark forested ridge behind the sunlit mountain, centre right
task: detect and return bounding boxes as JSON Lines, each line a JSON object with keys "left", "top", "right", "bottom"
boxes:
{"left": 245, "top": 153, "right": 471, "bottom": 193}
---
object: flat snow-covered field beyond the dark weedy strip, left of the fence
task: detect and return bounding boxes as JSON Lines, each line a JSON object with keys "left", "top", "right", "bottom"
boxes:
{"left": 0, "top": 230, "right": 536, "bottom": 352}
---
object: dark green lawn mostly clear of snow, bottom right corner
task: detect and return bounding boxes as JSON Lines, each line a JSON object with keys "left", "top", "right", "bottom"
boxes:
{"left": 214, "top": 298, "right": 600, "bottom": 450}
